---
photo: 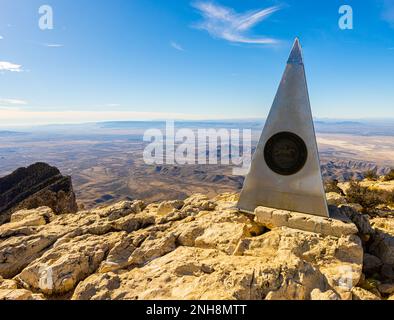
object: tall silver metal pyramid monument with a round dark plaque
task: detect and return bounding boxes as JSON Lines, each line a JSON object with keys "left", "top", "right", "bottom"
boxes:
{"left": 238, "top": 39, "right": 329, "bottom": 217}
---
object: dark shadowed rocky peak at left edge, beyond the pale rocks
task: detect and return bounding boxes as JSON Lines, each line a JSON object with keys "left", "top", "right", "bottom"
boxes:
{"left": 0, "top": 163, "right": 78, "bottom": 225}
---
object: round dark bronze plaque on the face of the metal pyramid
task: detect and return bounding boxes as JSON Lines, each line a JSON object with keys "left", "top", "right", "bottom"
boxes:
{"left": 264, "top": 132, "right": 308, "bottom": 176}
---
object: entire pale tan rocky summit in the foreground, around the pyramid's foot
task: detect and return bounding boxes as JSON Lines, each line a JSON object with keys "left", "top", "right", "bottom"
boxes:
{"left": 0, "top": 188, "right": 394, "bottom": 300}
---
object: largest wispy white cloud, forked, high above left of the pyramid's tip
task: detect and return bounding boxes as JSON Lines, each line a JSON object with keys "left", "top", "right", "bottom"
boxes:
{"left": 192, "top": 1, "right": 280, "bottom": 44}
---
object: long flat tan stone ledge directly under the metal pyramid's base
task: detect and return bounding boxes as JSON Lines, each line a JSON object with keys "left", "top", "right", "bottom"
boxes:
{"left": 254, "top": 207, "right": 358, "bottom": 238}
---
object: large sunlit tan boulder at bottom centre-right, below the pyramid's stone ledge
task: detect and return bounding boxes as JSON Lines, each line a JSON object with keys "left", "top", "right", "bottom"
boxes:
{"left": 73, "top": 225, "right": 362, "bottom": 300}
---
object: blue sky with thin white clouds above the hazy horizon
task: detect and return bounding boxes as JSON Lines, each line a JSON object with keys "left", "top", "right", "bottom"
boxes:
{"left": 0, "top": 0, "right": 394, "bottom": 126}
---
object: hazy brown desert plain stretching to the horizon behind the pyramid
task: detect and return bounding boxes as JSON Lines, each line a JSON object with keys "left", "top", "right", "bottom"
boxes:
{"left": 0, "top": 121, "right": 394, "bottom": 207}
